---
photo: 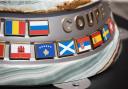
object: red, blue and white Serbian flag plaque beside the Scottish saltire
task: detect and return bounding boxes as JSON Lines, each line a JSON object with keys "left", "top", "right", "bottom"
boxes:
{"left": 76, "top": 36, "right": 92, "bottom": 53}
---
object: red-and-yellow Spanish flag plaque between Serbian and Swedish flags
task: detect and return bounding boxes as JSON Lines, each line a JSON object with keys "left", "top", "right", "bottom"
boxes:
{"left": 91, "top": 31, "right": 103, "bottom": 48}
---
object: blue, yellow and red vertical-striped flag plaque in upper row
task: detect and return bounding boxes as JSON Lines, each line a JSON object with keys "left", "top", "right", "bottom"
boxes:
{"left": 5, "top": 20, "right": 26, "bottom": 36}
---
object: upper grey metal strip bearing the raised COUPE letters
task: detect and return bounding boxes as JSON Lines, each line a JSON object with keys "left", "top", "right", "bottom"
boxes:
{"left": 0, "top": 3, "right": 110, "bottom": 43}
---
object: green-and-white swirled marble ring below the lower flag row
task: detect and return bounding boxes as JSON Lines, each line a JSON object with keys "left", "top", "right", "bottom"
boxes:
{"left": 0, "top": 24, "right": 119, "bottom": 85}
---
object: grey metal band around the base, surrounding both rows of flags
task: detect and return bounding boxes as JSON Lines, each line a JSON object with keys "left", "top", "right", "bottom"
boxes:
{"left": 0, "top": 3, "right": 114, "bottom": 64}
